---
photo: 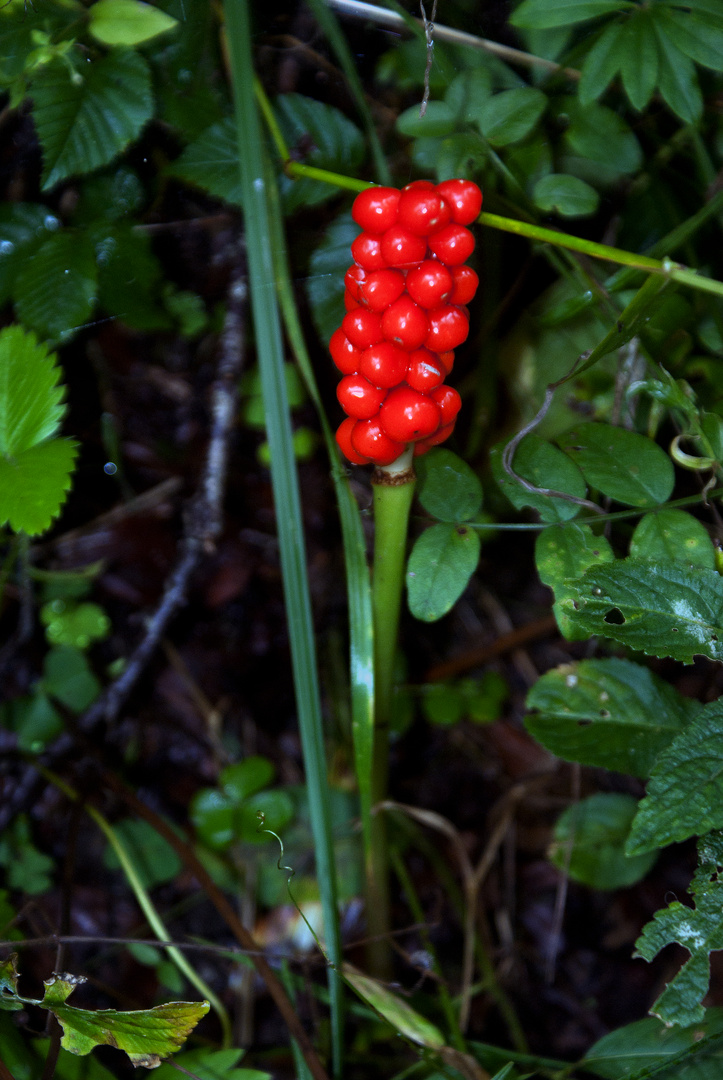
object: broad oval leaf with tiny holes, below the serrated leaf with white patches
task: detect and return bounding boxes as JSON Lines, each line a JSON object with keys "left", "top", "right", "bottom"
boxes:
{"left": 525, "top": 658, "right": 701, "bottom": 778}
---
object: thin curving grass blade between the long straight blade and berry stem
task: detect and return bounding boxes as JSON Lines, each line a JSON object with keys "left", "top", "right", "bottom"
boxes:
{"left": 267, "top": 157, "right": 375, "bottom": 858}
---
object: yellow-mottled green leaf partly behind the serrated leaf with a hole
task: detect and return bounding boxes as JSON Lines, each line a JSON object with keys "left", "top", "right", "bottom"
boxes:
{"left": 535, "top": 522, "right": 615, "bottom": 642}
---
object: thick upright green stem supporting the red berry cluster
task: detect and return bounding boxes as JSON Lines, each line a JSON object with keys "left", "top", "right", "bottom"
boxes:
{"left": 366, "top": 448, "right": 415, "bottom": 978}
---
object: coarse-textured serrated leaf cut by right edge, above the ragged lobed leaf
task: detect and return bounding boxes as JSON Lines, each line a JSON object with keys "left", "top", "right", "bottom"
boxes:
{"left": 628, "top": 701, "right": 723, "bottom": 854}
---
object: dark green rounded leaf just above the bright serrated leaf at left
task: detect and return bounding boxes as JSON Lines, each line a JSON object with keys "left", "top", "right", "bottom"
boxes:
{"left": 13, "top": 229, "right": 97, "bottom": 341}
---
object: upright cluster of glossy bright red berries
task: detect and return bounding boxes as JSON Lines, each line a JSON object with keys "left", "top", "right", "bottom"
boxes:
{"left": 330, "top": 180, "right": 482, "bottom": 465}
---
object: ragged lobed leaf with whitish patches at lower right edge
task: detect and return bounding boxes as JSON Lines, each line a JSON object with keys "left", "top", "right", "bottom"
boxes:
{"left": 634, "top": 834, "right": 723, "bottom": 1025}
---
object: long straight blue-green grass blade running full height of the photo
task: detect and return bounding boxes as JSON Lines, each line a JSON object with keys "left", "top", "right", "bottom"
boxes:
{"left": 224, "top": 0, "right": 344, "bottom": 1076}
